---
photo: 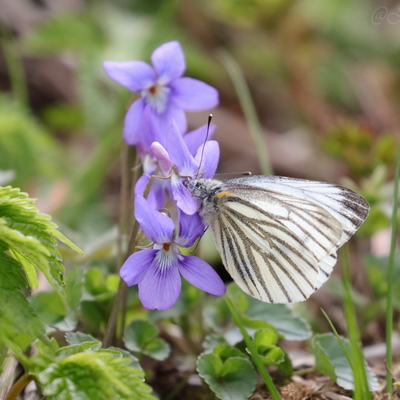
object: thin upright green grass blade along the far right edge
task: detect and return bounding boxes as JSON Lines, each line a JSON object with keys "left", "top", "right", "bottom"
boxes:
{"left": 386, "top": 146, "right": 400, "bottom": 393}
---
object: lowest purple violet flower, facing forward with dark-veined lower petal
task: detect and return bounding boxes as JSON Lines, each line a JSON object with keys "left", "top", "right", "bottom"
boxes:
{"left": 120, "top": 196, "right": 226, "bottom": 310}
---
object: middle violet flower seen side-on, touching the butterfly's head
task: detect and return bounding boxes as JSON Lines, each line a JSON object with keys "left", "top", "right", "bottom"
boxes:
{"left": 135, "top": 122, "right": 219, "bottom": 211}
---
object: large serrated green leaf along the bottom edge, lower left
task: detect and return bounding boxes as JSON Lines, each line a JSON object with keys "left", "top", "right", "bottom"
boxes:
{"left": 38, "top": 348, "right": 155, "bottom": 400}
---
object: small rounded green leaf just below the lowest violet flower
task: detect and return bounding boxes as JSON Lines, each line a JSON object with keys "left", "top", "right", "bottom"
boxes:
{"left": 123, "top": 319, "right": 171, "bottom": 360}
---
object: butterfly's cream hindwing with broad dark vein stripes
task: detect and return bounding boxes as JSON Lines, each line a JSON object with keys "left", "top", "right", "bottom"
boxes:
{"left": 205, "top": 189, "right": 341, "bottom": 303}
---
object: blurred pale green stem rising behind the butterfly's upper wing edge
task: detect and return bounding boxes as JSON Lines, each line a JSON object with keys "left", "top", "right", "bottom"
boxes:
{"left": 218, "top": 50, "right": 272, "bottom": 175}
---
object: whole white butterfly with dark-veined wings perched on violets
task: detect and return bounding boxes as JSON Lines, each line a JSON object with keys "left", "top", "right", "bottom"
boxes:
{"left": 185, "top": 176, "right": 369, "bottom": 303}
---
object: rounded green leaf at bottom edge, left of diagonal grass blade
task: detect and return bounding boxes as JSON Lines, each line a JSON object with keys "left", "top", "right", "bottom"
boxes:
{"left": 197, "top": 352, "right": 257, "bottom": 400}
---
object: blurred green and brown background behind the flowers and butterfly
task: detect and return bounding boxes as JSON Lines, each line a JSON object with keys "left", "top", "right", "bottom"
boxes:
{"left": 0, "top": 0, "right": 400, "bottom": 321}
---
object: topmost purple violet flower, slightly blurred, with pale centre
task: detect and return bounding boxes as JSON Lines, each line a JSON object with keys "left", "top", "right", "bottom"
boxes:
{"left": 103, "top": 41, "right": 218, "bottom": 145}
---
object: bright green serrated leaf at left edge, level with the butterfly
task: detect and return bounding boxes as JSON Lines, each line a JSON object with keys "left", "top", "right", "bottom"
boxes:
{"left": 0, "top": 186, "right": 81, "bottom": 295}
